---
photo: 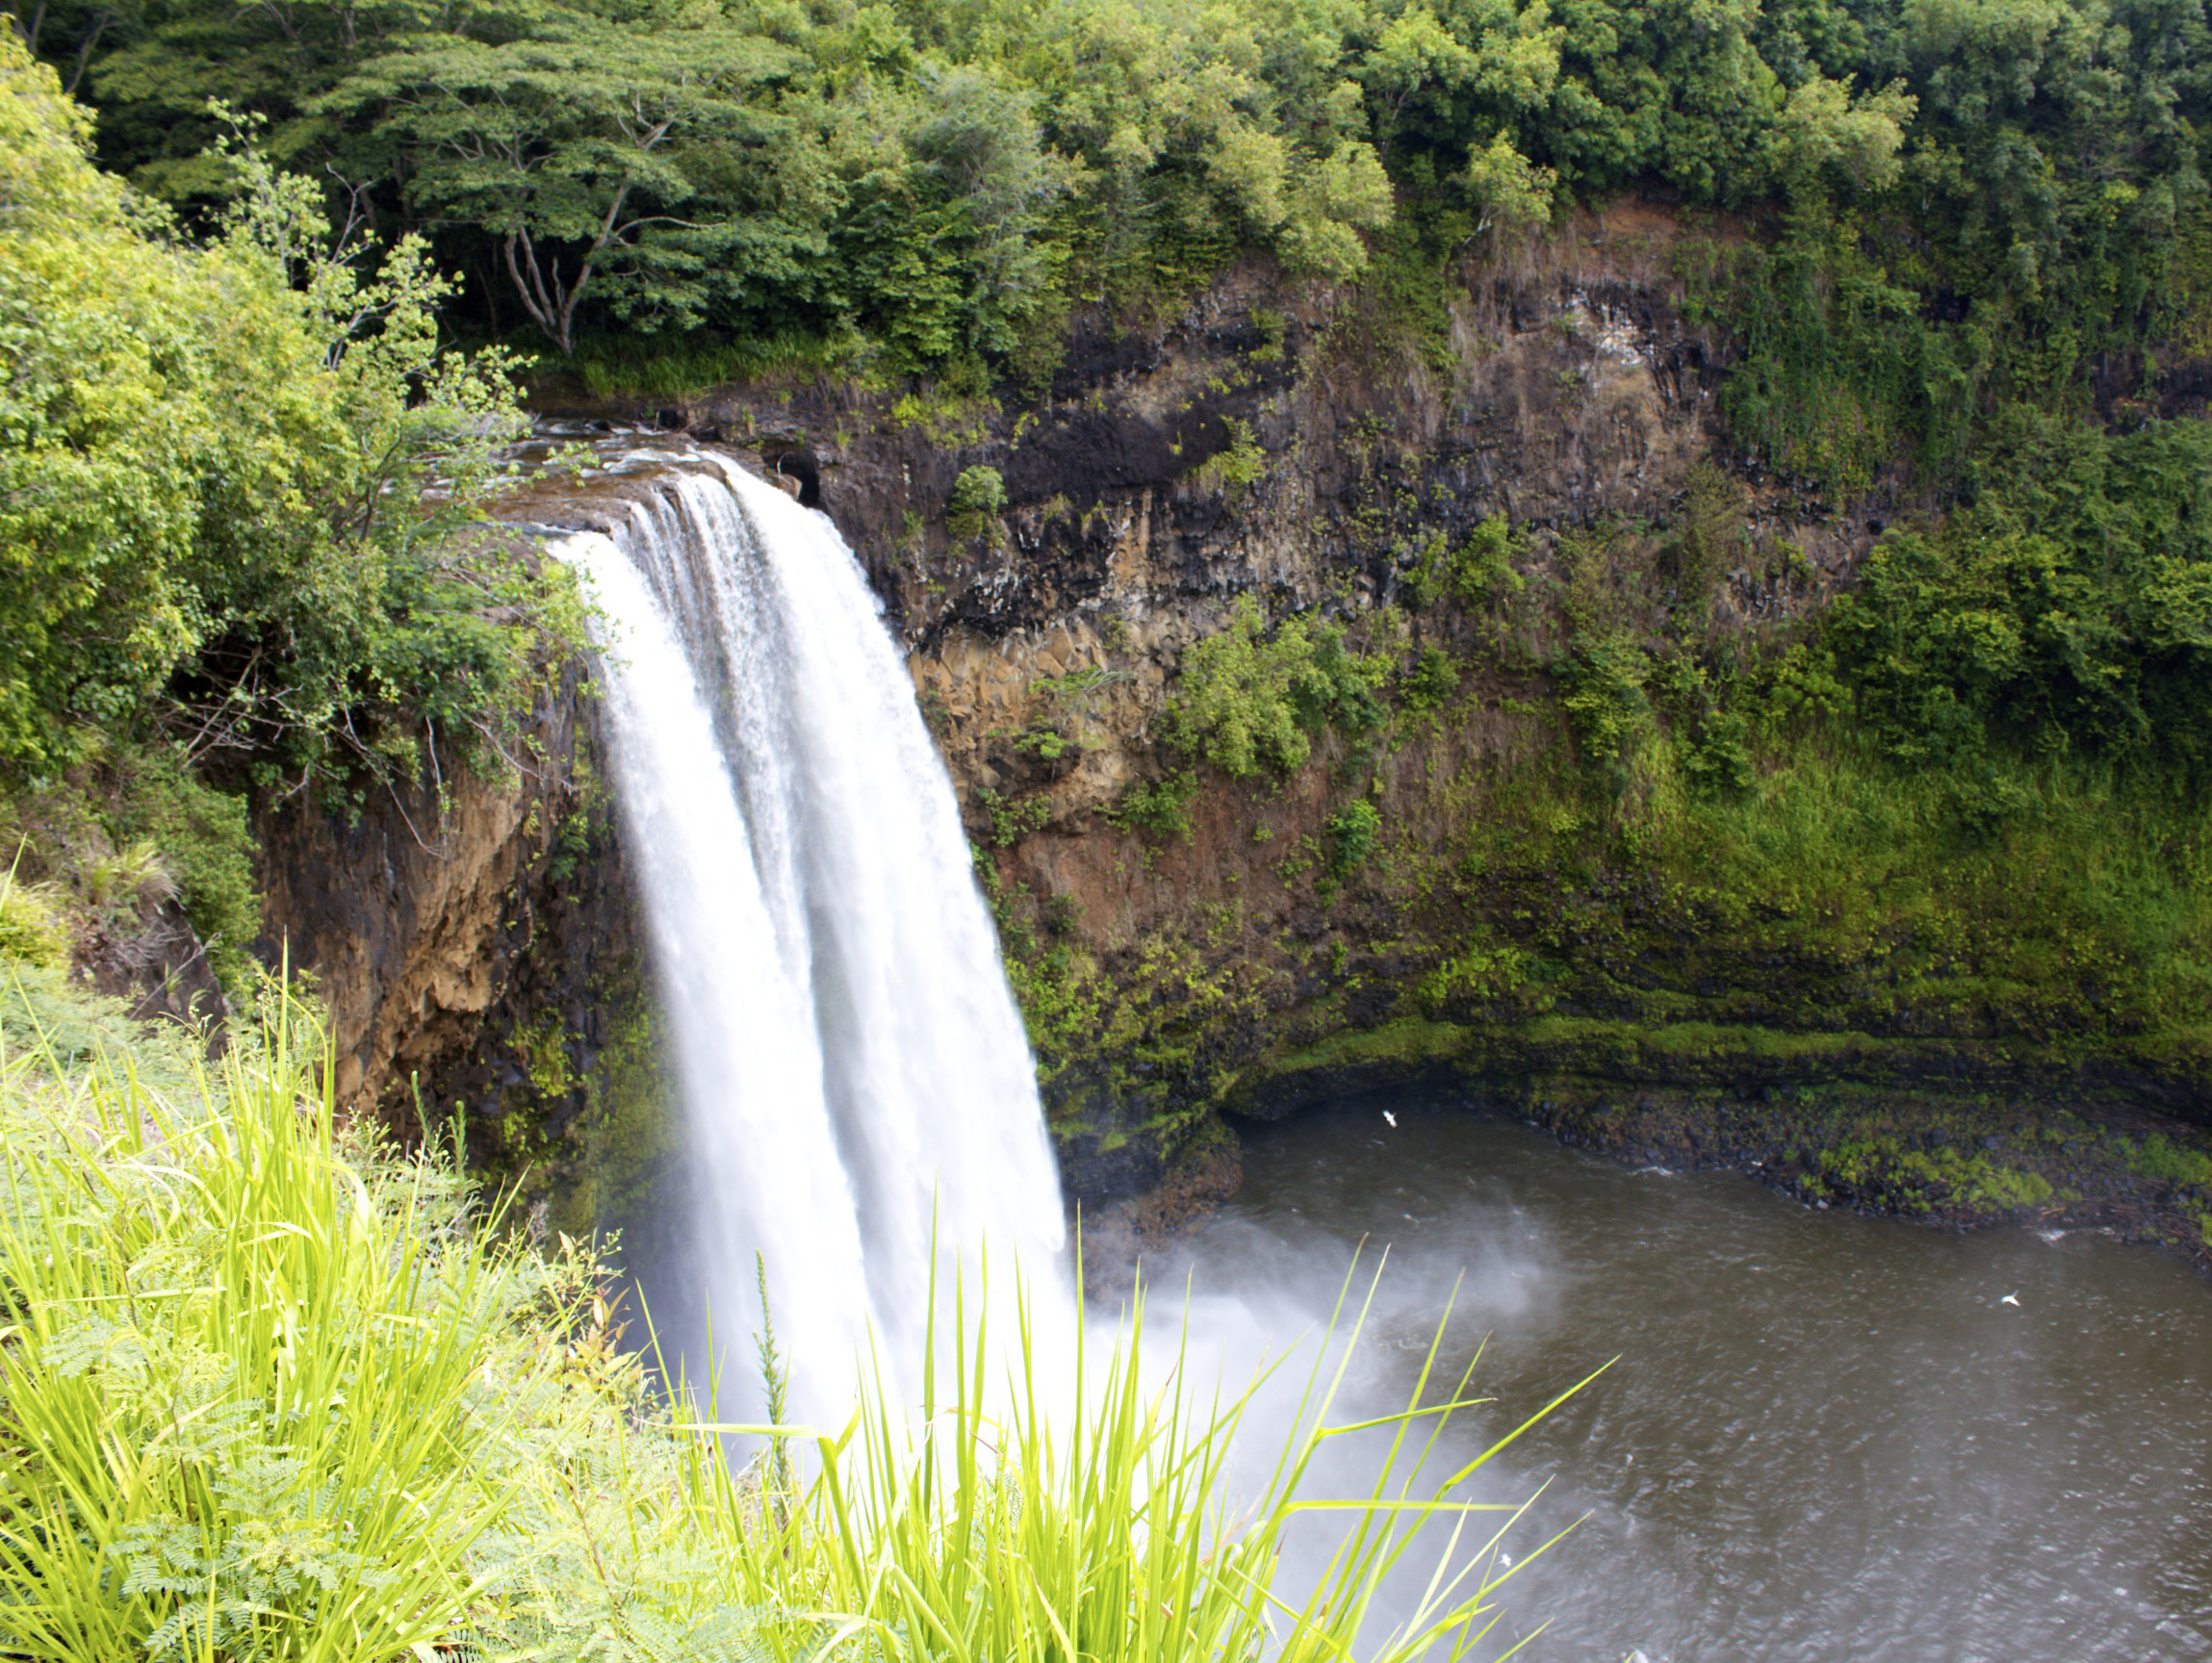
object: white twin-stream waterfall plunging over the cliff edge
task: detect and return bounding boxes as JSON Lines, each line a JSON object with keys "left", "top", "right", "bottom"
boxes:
{"left": 553, "top": 455, "right": 1064, "bottom": 1420}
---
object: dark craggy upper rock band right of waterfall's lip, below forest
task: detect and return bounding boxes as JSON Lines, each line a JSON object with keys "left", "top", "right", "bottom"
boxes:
{"left": 663, "top": 203, "right": 1893, "bottom": 760}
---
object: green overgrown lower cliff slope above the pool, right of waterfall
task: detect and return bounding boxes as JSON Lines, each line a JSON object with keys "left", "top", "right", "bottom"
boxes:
{"left": 1000, "top": 407, "right": 2212, "bottom": 1245}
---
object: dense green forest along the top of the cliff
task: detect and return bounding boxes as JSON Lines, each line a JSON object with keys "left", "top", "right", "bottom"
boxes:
{"left": 13, "top": 0, "right": 2212, "bottom": 409}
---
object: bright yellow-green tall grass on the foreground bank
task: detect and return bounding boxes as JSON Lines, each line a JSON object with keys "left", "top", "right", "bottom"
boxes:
{"left": 0, "top": 982, "right": 1575, "bottom": 1663}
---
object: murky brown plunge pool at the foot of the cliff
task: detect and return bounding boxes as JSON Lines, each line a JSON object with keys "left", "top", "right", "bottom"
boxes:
{"left": 1190, "top": 1099, "right": 2212, "bottom": 1663}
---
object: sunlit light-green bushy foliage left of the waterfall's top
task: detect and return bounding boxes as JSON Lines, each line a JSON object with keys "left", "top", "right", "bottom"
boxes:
{"left": 0, "top": 31, "right": 579, "bottom": 780}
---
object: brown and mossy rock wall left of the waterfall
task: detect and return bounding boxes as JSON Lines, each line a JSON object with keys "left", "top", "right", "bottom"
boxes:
{"left": 259, "top": 670, "right": 673, "bottom": 1230}
